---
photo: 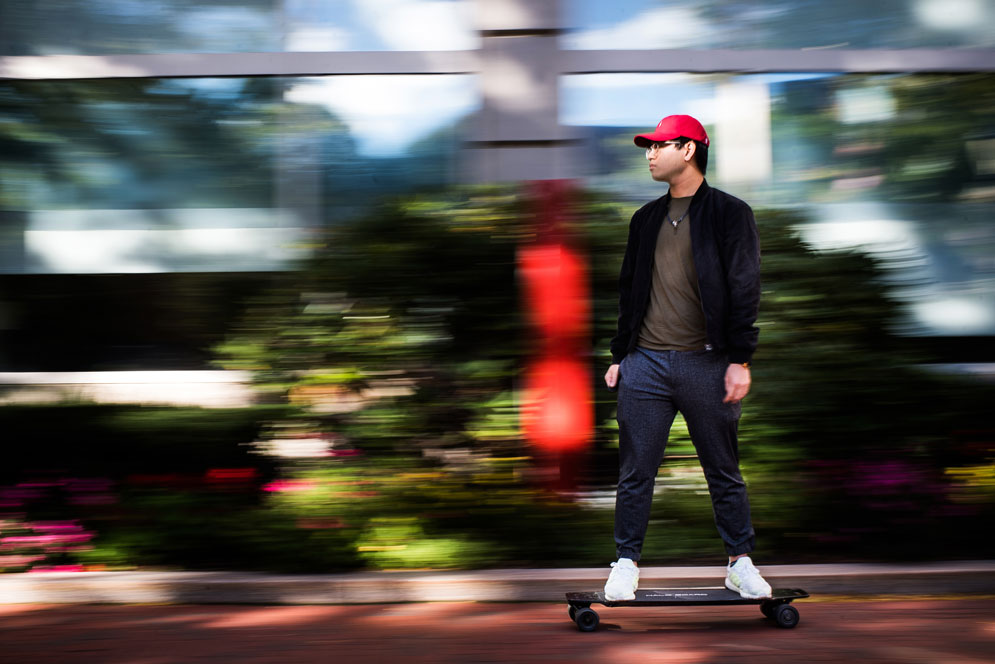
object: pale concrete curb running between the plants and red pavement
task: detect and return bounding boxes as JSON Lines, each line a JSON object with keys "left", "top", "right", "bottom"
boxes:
{"left": 0, "top": 561, "right": 995, "bottom": 604}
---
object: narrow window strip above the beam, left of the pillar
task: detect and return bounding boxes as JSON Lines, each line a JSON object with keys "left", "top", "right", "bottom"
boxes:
{"left": 0, "top": 0, "right": 478, "bottom": 55}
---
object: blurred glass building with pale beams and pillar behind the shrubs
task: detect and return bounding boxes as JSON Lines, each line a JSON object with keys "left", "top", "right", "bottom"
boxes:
{"left": 0, "top": 0, "right": 995, "bottom": 394}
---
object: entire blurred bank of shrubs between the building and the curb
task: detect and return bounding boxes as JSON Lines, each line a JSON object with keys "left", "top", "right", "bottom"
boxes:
{"left": 0, "top": 187, "right": 995, "bottom": 571}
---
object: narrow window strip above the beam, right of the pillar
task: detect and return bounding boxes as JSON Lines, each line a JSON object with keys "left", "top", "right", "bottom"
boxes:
{"left": 563, "top": 0, "right": 995, "bottom": 49}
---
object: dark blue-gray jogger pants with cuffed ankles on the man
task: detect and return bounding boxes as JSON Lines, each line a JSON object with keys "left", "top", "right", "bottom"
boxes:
{"left": 615, "top": 348, "right": 754, "bottom": 560}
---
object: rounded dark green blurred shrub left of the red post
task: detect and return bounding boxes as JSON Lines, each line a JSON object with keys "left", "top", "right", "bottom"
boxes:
{"left": 218, "top": 188, "right": 534, "bottom": 454}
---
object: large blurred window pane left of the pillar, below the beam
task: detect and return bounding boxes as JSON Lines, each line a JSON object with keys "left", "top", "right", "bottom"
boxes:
{"left": 0, "top": 75, "right": 478, "bottom": 274}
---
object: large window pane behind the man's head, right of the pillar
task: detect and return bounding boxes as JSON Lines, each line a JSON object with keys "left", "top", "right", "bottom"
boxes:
{"left": 561, "top": 74, "right": 995, "bottom": 335}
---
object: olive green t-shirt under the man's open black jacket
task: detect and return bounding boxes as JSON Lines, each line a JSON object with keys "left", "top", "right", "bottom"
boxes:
{"left": 638, "top": 196, "right": 707, "bottom": 350}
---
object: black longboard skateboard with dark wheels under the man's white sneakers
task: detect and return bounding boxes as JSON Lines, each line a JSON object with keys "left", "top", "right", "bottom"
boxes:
{"left": 567, "top": 588, "right": 808, "bottom": 632}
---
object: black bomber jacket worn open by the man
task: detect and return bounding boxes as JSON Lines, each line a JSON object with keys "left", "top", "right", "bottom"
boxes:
{"left": 611, "top": 181, "right": 760, "bottom": 364}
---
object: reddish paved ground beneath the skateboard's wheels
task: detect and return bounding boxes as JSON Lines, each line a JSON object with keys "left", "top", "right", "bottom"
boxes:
{"left": 0, "top": 596, "right": 995, "bottom": 664}
